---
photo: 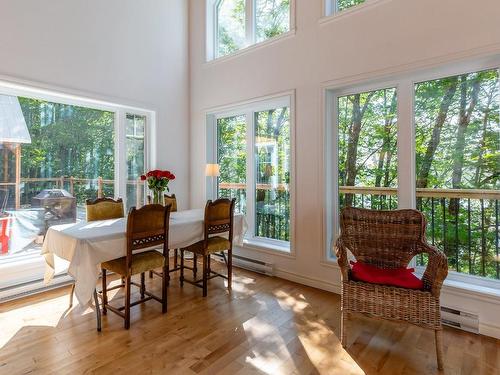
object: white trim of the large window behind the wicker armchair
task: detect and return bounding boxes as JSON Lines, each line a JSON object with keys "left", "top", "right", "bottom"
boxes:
{"left": 321, "top": 55, "right": 500, "bottom": 292}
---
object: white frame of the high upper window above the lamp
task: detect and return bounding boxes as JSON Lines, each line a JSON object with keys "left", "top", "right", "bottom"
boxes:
{"left": 205, "top": 0, "right": 296, "bottom": 63}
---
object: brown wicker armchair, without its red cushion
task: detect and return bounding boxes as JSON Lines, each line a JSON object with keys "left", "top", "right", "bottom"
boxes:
{"left": 335, "top": 207, "right": 448, "bottom": 370}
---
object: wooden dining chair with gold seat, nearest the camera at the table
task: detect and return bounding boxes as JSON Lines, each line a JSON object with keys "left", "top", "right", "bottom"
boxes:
{"left": 101, "top": 204, "right": 170, "bottom": 329}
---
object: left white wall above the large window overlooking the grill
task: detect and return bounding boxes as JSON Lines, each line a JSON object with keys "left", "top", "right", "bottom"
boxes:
{"left": 0, "top": 0, "right": 189, "bottom": 207}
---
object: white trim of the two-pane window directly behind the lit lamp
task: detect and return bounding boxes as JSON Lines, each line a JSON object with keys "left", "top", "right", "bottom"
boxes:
{"left": 205, "top": 91, "right": 296, "bottom": 256}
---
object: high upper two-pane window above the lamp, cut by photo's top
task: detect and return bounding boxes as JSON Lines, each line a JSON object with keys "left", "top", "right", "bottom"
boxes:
{"left": 211, "top": 0, "right": 291, "bottom": 59}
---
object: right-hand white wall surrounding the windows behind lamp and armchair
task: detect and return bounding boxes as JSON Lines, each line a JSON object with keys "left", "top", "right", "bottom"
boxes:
{"left": 189, "top": 0, "right": 500, "bottom": 337}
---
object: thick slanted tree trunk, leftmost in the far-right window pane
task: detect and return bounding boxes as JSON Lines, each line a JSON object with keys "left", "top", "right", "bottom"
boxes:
{"left": 417, "top": 77, "right": 458, "bottom": 188}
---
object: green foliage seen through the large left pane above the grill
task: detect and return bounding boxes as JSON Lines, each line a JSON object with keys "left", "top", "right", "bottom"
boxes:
{"left": 18, "top": 97, "right": 115, "bottom": 204}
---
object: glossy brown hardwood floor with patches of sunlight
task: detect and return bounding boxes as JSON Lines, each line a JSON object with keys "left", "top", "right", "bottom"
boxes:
{"left": 0, "top": 269, "right": 500, "bottom": 375}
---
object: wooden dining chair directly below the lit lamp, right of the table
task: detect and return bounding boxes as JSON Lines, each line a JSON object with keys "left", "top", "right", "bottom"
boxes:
{"left": 180, "top": 199, "right": 236, "bottom": 297}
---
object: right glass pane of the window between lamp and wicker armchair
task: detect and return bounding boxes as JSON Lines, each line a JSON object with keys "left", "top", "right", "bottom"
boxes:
{"left": 255, "top": 107, "right": 290, "bottom": 241}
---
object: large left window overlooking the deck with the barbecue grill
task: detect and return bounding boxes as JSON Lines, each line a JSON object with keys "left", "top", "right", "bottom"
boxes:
{"left": 0, "top": 86, "right": 149, "bottom": 293}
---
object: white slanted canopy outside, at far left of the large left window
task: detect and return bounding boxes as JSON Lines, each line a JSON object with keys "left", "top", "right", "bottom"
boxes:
{"left": 0, "top": 95, "right": 31, "bottom": 143}
